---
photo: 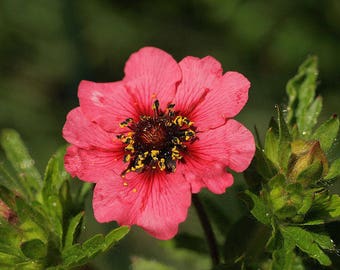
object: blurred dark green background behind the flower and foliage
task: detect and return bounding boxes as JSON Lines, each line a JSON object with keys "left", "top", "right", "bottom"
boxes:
{"left": 0, "top": 0, "right": 340, "bottom": 270}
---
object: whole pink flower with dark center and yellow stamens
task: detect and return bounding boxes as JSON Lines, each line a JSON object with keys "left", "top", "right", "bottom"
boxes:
{"left": 63, "top": 47, "right": 255, "bottom": 239}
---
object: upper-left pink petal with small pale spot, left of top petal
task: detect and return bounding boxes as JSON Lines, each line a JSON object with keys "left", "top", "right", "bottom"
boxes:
{"left": 78, "top": 81, "right": 139, "bottom": 132}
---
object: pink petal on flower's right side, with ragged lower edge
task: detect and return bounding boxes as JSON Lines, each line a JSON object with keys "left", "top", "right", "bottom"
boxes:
{"left": 179, "top": 120, "right": 255, "bottom": 193}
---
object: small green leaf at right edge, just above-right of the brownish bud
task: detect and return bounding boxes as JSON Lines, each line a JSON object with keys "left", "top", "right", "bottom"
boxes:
{"left": 312, "top": 115, "right": 339, "bottom": 152}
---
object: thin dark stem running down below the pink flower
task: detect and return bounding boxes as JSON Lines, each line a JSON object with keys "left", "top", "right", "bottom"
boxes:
{"left": 192, "top": 194, "right": 220, "bottom": 266}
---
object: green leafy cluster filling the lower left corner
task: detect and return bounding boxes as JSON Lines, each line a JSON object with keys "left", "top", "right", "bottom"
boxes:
{"left": 0, "top": 130, "right": 129, "bottom": 269}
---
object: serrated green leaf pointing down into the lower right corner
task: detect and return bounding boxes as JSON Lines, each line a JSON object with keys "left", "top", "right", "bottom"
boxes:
{"left": 280, "top": 226, "right": 331, "bottom": 266}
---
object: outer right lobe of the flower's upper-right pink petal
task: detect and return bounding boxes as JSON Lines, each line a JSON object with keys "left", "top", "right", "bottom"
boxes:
{"left": 190, "top": 71, "right": 250, "bottom": 131}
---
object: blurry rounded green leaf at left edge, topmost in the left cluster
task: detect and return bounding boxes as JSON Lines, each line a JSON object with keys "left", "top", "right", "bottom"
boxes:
{"left": 0, "top": 129, "right": 42, "bottom": 199}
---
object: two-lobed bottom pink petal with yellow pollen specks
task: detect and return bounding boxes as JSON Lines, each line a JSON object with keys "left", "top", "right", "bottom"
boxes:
{"left": 93, "top": 173, "right": 191, "bottom": 240}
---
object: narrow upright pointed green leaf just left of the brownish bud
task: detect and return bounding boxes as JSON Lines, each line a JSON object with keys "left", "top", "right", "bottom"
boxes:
{"left": 276, "top": 106, "right": 292, "bottom": 171}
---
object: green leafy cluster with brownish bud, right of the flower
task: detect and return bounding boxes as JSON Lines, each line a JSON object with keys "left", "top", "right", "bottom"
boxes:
{"left": 243, "top": 57, "right": 340, "bottom": 269}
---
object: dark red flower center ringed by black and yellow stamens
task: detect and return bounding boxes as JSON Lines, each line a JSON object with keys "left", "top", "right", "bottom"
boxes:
{"left": 117, "top": 100, "right": 197, "bottom": 177}
